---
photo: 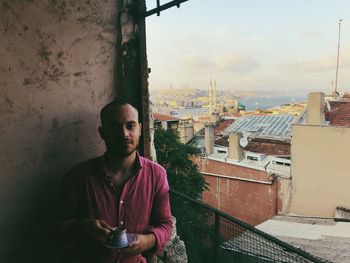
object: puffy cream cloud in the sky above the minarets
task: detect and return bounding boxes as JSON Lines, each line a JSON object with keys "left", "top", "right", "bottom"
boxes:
{"left": 184, "top": 53, "right": 259, "bottom": 74}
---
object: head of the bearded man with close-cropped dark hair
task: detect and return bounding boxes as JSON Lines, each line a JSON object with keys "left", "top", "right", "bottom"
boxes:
{"left": 99, "top": 104, "right": 141, "bottom": 157}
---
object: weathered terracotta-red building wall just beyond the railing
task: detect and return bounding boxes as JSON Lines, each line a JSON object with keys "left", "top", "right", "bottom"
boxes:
{"left": 196, "top": 158, "right": 280, "bottom": 225}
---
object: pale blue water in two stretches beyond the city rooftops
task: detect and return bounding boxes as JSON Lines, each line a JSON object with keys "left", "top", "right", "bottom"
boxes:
{"left": 171, "top": 95, "right": 307, "bottom": 118}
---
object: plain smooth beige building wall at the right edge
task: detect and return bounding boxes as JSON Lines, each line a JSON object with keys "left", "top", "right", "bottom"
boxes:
{"left": 288, "top": 125, "right": 350, "bottom": 217}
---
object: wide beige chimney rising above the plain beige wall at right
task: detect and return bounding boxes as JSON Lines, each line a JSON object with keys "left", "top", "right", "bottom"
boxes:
{"left": 306, "top": 92, "right": 325, "bottom": 125}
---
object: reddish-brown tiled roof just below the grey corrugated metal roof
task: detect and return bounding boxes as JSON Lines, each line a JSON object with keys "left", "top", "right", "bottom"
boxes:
{"left": 215, "top": 136, "right": 290, "bottom": 156}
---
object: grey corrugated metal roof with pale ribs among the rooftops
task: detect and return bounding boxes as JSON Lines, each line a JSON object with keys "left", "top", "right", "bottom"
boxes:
{"left": 224, "top": 115, "right": 295, "bottom": 138}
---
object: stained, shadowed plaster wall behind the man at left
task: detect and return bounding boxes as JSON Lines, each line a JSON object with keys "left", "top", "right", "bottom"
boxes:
{"left": 0, "top": 0, "right": 116, "bottom": 262}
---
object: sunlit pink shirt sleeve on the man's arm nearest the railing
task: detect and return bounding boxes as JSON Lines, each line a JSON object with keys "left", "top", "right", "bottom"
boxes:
{"left": 149, "top": 168, "right": 173, "bottom": 253}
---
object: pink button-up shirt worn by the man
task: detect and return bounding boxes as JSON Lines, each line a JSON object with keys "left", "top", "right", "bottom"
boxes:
{"left": 60, "top": 154, "right": 172, "bottom": 263}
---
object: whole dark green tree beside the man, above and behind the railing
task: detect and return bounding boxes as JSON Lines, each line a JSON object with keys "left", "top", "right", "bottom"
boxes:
{"left": 154, "top": 129, "right": 214, "bottom": 262}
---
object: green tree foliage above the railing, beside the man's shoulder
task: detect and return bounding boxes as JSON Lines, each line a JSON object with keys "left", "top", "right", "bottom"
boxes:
{"left": 154, "top": 129, "right": 205, "bottom": 198}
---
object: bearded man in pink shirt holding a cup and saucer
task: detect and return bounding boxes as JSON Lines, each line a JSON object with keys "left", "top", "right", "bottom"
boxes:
{"left": 59, "top": 101, "right": 172, "bottom": 263}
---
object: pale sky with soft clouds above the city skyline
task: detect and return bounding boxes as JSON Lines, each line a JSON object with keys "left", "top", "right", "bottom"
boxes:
{"left": 146, "top": 0, "right": 350, "bottom": 94}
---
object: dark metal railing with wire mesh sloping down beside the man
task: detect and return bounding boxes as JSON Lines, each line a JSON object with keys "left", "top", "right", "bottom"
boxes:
{"left": 170, "top": 190, "right": 329, "bottom": 263}
